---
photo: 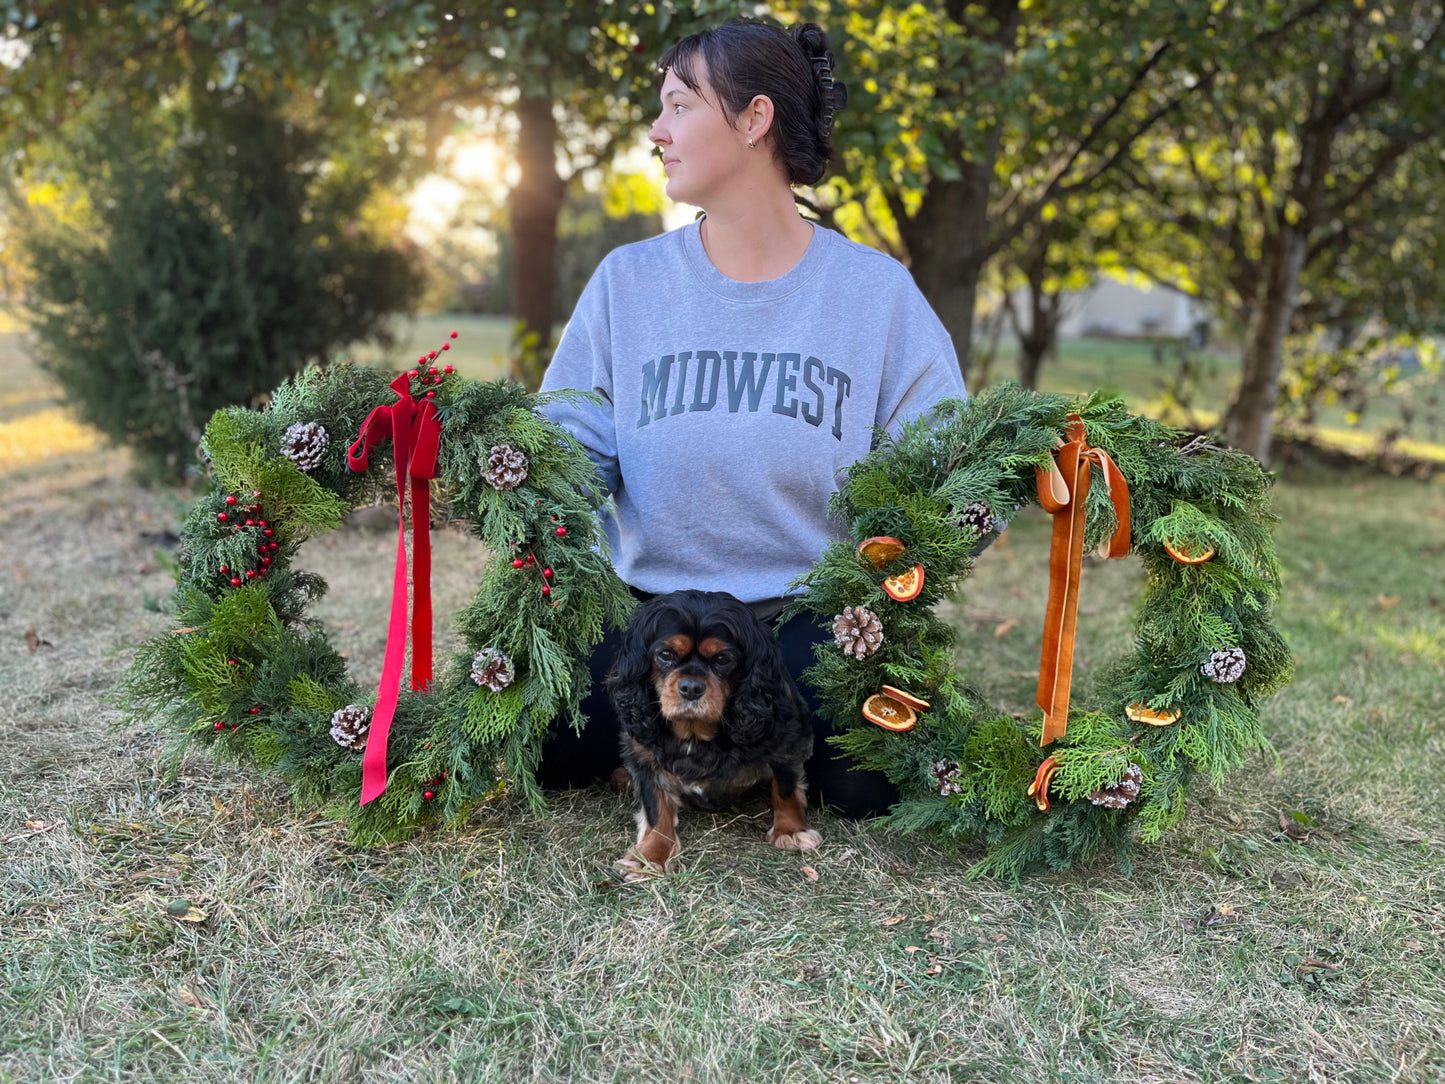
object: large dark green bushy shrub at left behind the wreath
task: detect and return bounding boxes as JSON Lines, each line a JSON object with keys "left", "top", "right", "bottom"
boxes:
{"left": 25, "top": 94, "right": 422, "bottom": 478}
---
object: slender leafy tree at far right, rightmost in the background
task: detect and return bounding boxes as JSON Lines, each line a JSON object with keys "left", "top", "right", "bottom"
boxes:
{"left": 1129, "top": 0, "right": 1445, "bottom": 461}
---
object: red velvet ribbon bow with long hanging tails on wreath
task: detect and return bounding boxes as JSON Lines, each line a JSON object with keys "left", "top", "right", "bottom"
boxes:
{"left": 347, "top": 373, "right": 442, "bottom": 805}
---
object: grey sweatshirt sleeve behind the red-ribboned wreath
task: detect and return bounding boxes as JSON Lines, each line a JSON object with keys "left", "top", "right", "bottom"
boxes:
{"left": 542, "top": 260, "right": 621, "bottom": 494}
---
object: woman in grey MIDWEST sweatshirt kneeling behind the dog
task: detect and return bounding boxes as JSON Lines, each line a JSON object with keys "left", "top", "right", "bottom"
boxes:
{"left": 539, "top": 22, "right": 964, "bottom": 817}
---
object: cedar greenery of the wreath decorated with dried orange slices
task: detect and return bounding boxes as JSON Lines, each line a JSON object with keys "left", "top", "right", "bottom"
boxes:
{"left": 789, "top": 384, "right": 1290, "bottom": 880}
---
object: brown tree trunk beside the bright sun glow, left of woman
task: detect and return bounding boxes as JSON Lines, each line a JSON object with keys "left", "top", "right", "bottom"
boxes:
{"left": 507, "top": 94, "right": 566, "bottom": 392}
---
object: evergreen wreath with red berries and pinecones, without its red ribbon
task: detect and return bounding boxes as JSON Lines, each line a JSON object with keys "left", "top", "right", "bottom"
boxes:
{"left": 120, "top": 352, "right": 634, "bottom": 843}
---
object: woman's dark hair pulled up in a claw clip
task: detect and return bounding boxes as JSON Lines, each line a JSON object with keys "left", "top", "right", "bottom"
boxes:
{"left": 657, "top": 20, "right": 848, "bottom": 185}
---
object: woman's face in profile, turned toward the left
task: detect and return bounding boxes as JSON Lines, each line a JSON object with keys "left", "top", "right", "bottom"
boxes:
{"left": 647, "top": 56, "right": 763, "bottom": 210}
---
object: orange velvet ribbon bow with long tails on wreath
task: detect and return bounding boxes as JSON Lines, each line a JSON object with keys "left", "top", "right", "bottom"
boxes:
{"left": 1035, "top": 413, "right": 1129, "bottom": 746}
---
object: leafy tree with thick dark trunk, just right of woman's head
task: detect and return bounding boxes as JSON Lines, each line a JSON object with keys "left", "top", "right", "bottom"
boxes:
{"left": 806, "top": 0, "right": 1324, "bottom": 376}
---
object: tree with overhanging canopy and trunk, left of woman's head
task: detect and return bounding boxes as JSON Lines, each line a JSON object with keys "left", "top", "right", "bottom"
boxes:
{"left": 0, "top": 0, "right": 719, "bottom": 387}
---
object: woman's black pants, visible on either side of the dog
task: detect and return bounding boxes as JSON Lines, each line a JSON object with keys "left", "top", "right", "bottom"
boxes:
{"left": 538, "top": 593, "right": 899, "bottom": 820}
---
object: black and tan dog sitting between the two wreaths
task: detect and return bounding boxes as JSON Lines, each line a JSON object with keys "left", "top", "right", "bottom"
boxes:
{"left": 607, "top": 591, "right": 822, "bottom": 879}
